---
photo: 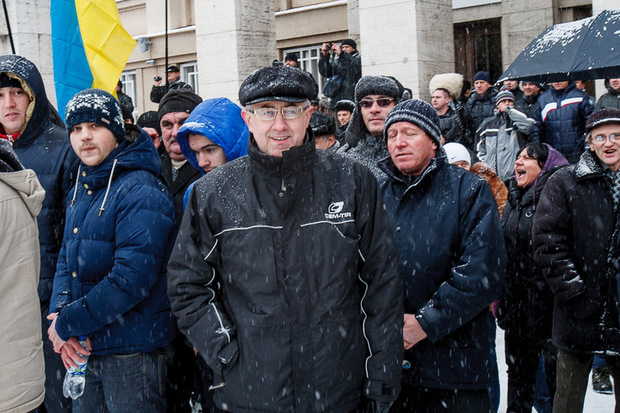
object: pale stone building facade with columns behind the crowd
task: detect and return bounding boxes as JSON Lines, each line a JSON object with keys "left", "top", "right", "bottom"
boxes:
{"left": 0, "top": 0, "right": 618, "bottom": 115}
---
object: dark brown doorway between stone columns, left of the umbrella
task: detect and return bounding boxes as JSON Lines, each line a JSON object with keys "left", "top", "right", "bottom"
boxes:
{"left": 454, "top": 19, "right": 503, "bottom": 82}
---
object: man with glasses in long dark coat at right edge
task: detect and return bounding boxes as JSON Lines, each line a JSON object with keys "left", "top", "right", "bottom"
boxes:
{"left": 533, "top": 108, "right": 620, "bottom": 413}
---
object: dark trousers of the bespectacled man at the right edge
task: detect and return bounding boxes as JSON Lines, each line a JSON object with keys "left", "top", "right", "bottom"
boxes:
{"left": 553, "top": 350, "right": 620, "bottom": 413}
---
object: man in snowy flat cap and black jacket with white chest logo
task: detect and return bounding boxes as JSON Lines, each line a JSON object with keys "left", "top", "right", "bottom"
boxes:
{"left": 168, "top": 66, "right": 403, "bottom": 412}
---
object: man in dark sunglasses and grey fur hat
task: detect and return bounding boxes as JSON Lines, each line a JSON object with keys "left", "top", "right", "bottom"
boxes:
{"left": 339, "top": 76, "right": 404, "bottom": 181}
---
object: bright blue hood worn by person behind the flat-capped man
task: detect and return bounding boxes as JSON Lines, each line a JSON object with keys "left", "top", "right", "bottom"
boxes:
{"left": 177, "top": 98, "right": 250, "bottom": 175}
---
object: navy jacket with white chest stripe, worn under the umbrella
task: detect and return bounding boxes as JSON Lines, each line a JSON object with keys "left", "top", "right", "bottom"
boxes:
{"left": 530, "top": 82, "right": 594, "bottom": 163}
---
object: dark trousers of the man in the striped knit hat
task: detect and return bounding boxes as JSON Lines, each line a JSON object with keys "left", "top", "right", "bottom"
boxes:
{"left": 390, "top": 382, "right": 491, "bottom": 413}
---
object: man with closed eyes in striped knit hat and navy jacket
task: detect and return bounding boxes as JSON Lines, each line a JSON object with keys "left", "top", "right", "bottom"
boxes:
{"left": 380, "top": 100, "right": 506, "bottom": 413}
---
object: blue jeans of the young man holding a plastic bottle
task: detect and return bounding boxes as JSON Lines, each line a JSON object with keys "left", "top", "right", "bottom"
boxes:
{"left": 73, "top": 346, "right": 173, "bottom": 413}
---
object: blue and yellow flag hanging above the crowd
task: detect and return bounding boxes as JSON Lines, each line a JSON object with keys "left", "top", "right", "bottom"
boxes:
{"left": 50, "top": 0, "right": 136, "bottom": 115}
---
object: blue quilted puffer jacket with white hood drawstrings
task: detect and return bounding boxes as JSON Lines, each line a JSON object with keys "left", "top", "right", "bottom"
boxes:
{"left": 50, "top": 127, "right": 175, "bottom": 355}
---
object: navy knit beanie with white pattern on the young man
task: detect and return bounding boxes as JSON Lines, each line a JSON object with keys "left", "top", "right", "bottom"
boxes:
{"left": 65, "top": 89, "right": 125, "bottom": 143}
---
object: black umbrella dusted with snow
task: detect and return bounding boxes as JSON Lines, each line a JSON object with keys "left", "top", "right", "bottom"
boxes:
{"left": 498, "top": 10, "right": 620, "bottom": 83}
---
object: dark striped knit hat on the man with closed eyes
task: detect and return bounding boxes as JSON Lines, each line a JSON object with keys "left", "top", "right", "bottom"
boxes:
{"left": 383, "top": 99, "right": 441, "bottom": 147}
